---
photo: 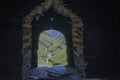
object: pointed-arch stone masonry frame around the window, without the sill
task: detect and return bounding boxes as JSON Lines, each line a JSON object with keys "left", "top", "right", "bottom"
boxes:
{"left": 21, "top": 0, "right": 85, "bottom": 80}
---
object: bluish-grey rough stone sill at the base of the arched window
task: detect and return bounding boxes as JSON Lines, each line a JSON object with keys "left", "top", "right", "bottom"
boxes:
{"left": 28, "top": 65, "right": 82, "bottom": 80}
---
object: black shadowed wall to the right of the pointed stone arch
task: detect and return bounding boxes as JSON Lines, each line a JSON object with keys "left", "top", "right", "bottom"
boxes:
{"left": 80, "top": 0, "right": 120, "bottom": 80}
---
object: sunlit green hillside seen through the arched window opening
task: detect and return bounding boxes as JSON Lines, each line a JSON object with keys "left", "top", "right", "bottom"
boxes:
{"left": 38, "top": 32, "right": 67, "bottom": 66}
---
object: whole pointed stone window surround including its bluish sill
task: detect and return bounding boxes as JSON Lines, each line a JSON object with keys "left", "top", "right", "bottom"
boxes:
{"left": 21, "top": 0, "right": 86, "bottom": 80}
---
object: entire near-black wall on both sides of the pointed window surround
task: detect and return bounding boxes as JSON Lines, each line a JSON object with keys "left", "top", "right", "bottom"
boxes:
{"left": 0, "top": 0, "right": 120, "bottom": 80}
